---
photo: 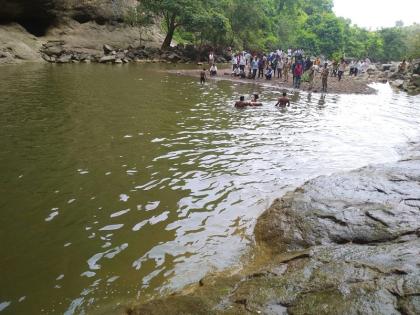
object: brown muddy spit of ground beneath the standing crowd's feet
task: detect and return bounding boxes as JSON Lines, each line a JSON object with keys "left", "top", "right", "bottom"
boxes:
{"left": 171, "top": 69, "right": 379, "bottom": 94}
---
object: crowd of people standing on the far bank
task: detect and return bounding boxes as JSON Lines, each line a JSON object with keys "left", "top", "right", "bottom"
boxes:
{"left": 202, "top": 48, "right": 371, "bottom": 92}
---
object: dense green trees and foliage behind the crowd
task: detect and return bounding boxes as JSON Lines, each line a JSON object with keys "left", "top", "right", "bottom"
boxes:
{"left": 133, "top": 0, "right": 420, "bottom": 61}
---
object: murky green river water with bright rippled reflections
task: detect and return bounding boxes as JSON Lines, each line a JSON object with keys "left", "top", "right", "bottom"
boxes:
{"left": 0, "top": 65, "right": 420, "bottom": 314}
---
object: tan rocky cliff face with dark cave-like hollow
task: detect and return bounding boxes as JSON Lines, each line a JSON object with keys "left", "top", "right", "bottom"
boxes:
{"left": 0, "top": 0, "right": 167, "bottom": 64}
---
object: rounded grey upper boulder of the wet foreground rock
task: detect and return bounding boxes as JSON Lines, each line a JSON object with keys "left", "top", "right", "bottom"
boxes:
{"left": 255, "top": 153, "right": 420, "bottom": 251}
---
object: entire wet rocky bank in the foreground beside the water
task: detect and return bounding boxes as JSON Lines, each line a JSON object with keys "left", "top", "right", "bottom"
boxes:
{"left": 124, "top": 145, "right": 420, "bottom": 315}
